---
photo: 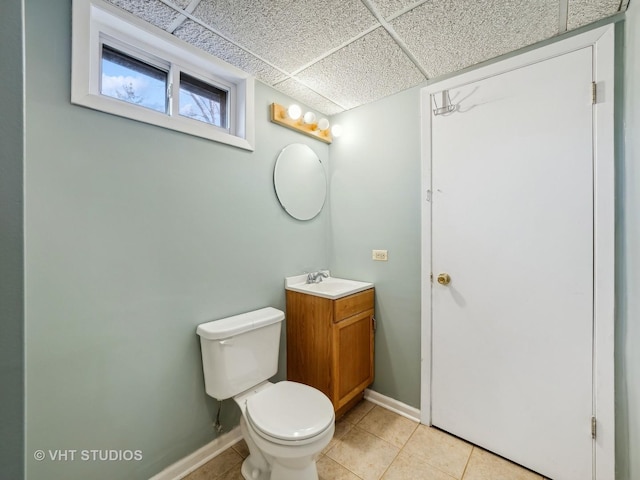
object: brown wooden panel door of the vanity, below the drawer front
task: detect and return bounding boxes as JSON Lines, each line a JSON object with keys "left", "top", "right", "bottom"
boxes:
{"left": 333, "top": 310, "right": 373, "bottom": 410}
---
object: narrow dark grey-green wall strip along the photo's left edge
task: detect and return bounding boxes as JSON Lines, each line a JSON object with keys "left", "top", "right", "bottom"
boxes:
{"left": 0, "top": 0, "right": 24, "bottom": 480}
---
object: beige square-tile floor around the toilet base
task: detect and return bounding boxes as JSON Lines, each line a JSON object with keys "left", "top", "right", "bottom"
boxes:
{"left": 185, "top": 400, "right": 544, "bottom": 480}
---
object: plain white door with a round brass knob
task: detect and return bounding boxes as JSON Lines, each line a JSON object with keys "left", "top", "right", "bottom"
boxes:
{"left": 431, "top": 47, "right": 594, "bottom": 480}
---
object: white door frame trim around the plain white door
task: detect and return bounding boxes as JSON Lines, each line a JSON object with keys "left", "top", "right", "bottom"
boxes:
{"left": 420, "top": 24, "right": 615, "bottom": 480}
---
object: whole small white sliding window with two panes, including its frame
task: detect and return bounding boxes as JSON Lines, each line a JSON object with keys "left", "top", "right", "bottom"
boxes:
{"left": 71, "top": 0, "right": 254, "bottom": 150}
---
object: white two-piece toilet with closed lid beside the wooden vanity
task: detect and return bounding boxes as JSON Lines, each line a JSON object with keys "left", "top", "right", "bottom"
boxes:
{"left": 196, "top": 307, "right": 335, "bottom": 480}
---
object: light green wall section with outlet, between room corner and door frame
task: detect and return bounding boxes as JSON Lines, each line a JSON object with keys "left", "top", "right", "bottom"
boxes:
{"left": 329, "top": 88, "right": 420, "bottom": 408}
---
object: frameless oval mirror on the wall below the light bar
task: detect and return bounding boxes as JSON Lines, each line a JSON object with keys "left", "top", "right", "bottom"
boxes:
{"left": 273, "top": 143, "right": 327, "bottom": 220}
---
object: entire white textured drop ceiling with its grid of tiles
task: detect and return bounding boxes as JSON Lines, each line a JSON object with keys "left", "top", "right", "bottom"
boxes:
{"left": 107, "top": 0, "right": 629, "bottom": 115}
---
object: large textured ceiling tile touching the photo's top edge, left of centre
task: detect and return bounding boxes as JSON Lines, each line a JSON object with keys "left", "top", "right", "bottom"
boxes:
{"left": 193, "top": 0, "right": 376, "bottom": 72}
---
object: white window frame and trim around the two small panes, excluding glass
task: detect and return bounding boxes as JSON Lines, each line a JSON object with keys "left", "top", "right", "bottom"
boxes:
{"left": 71, "top": 0, "right": 255, "bottom": 151}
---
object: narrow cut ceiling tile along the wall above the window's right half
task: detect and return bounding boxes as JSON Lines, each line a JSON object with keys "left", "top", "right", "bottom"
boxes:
{"left": 173, "top": 20, "right": 282, "bottom": 85}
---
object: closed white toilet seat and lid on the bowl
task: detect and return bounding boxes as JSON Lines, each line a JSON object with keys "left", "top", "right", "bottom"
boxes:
{"left": 246, "top": 381, "right": 335, "bottom": 445}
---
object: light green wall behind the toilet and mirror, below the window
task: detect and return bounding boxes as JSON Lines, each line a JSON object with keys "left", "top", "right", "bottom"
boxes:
{"left": 25, "top": 0, "right": 328, "bottom": 480}
